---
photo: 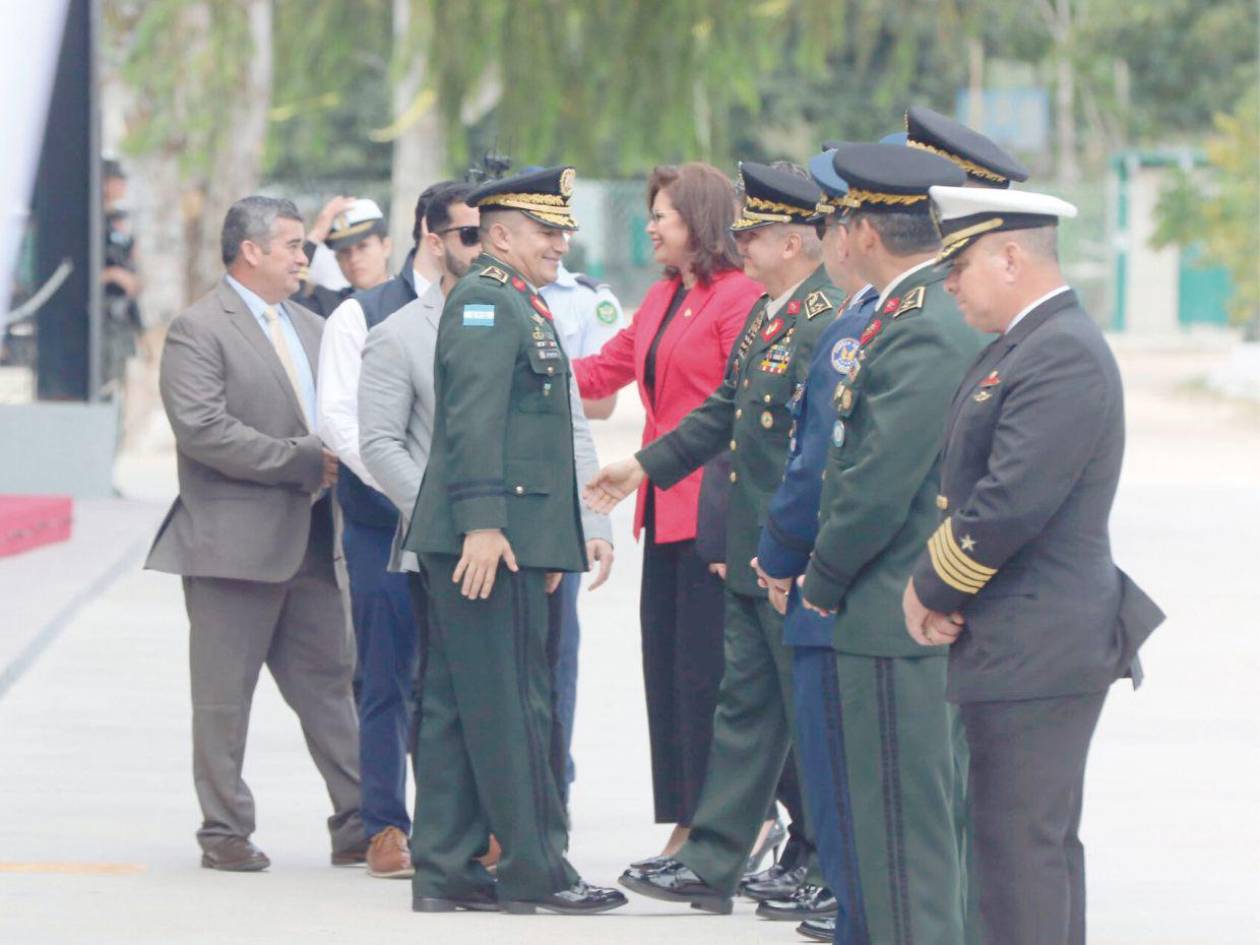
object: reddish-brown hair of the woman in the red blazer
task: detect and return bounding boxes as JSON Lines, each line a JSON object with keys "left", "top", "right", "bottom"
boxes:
{"left": 648, "top": 161, "right": 743, "bottom": 282}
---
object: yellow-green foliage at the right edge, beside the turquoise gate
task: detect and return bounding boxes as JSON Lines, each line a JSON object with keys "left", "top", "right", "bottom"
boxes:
{"left": 1154, "top": 87, "right": 1260, "bottom": 331}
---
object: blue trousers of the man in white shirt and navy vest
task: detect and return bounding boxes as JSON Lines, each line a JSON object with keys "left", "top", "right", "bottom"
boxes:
{"left": 341, "top": 520, "right": 417, "bottom": 838}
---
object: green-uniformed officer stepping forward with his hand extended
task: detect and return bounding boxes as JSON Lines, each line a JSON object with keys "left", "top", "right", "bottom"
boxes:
{"left": 585, "top": 163, "right": 844, "bottom": 919}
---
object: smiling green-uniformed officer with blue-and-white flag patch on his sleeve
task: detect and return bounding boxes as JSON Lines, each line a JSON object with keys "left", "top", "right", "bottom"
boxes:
{"left": 404, "top": 168, "right": 626, "bottom": 915}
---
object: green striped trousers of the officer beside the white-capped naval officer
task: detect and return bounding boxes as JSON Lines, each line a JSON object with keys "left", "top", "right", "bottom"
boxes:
{"left": 836, "top": 653, "right": 975, "bottom": 945}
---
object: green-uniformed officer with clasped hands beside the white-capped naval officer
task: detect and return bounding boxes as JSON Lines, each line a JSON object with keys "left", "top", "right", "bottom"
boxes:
{"left": 800, "top": 145, "right": 983, "bottom": 945}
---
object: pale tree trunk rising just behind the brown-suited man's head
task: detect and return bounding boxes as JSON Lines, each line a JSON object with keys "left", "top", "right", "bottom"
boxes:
{"left": 189, "top": 0, "right": 272, "bottom": 297}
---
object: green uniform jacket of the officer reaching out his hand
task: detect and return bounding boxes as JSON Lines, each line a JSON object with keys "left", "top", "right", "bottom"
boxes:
{"left": 636, "top": 266, "right": 844, "bottom": 597}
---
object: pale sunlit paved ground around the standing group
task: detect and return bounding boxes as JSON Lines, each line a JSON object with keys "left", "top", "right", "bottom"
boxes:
{"left": 0, "top": 353, "right": 1260, "bottom": 945}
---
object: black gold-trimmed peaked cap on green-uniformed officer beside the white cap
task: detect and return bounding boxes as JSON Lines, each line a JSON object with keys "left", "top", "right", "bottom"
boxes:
{"left": 832, "top": 144, "right": 966, "bottom": 214}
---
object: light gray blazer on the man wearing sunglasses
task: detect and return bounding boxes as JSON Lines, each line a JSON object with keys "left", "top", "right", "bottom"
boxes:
{"left": 359, "top": 282, "right": 612, "bottom": 571}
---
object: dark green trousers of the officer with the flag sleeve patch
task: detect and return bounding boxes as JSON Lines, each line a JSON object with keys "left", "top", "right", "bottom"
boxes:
{"left": 412, "top": 554, "right": 577, "bottom": 900}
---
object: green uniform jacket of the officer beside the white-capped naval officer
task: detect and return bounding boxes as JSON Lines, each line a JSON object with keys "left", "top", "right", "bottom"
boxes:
{"left": 803, "top": 262, "right": 983, "bottom": 656}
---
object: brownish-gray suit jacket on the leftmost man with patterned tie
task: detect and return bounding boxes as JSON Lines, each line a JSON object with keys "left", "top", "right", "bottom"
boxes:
{"left": 145, "top": 282, "right": 333, "bottom": 583}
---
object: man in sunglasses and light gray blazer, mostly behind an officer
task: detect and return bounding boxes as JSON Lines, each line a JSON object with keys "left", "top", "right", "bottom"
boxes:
{"left": 359, "top": 184, "right": 614, "bottom": 806}
